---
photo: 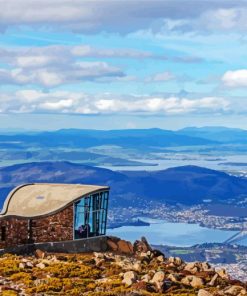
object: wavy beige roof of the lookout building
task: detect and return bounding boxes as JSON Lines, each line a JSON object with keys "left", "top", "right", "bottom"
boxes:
{"left": 0, "top": 183, "right": 109, "bottom": 218}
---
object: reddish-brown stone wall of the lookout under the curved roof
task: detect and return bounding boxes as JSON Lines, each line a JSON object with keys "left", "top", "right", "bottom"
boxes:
{"left": 0, "top": 205, "right": 73, "bottom": 249}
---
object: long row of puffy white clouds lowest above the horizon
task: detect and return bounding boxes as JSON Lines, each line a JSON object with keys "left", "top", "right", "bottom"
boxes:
{"left": 0, "top": 89, "right": 229, "bottom": 115}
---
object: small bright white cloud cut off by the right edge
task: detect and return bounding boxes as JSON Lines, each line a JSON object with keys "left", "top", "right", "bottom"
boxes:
{"left": 222, "top": 69, "right": 247, "bottom": 87}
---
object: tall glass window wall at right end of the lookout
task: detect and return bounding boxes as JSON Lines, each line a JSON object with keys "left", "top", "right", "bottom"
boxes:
{"left": 74, "top": 191, "right": 109, "bottom": 239}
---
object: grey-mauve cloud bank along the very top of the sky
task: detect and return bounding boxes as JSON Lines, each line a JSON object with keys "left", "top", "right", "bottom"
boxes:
{"left": 0, "top": 0, "right": 246, "bottom": 33}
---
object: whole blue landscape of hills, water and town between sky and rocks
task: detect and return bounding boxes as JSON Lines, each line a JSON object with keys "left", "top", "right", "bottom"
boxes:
{"left": 0, "top": 128, "right": 247, "bottom": 279}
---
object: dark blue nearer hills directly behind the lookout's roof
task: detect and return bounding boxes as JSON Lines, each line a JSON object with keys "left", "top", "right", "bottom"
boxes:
{"left": 0, "top": 162, "right": 247, "bottom": 206}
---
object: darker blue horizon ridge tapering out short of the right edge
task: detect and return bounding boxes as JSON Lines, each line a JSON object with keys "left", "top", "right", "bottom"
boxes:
{"left": 0, "top": 129, "right": 216, "bottom": 148}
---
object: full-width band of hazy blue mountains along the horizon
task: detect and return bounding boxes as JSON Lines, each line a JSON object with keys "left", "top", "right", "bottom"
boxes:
{"left": 0, "top": 127, "right": 247, "bottom": 149}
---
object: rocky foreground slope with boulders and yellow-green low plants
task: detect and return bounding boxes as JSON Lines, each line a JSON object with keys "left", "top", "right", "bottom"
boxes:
{"left": 0, "top": 238, "right": 247, "bottom": 296}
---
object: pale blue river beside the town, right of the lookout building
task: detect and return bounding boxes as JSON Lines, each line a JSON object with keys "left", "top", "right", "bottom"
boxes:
{"left": 107, "top": 218, "right": 247, "bottom": 247}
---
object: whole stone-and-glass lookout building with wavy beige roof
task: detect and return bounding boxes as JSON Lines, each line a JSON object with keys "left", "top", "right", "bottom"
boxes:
{"left": 0, "top": 183, "right": 109, "bottom": 251}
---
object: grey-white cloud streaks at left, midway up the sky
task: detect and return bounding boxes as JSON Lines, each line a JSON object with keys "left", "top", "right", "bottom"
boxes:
{"left": 0, "top": 45, "right": 163, "bottom": 88}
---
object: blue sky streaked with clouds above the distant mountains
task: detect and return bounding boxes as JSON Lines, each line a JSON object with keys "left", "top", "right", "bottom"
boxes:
{"left": 0, "top": 0, "right": 247, "bottom": 130}
